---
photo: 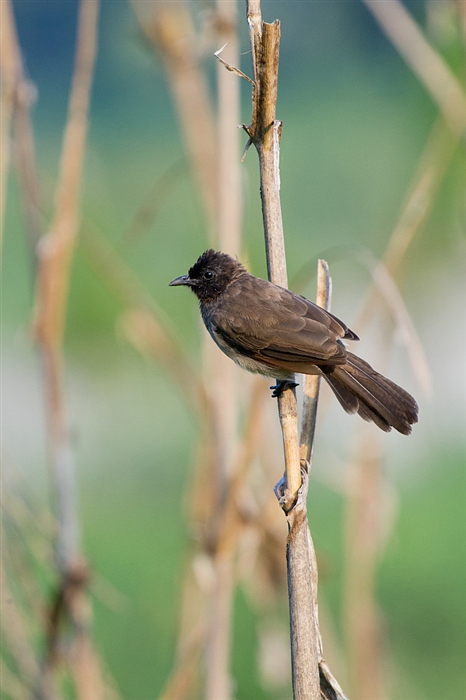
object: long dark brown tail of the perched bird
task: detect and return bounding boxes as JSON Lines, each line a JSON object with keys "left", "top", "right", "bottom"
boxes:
{"left": 322, "top": 352, "right": 418, "bottom": 435}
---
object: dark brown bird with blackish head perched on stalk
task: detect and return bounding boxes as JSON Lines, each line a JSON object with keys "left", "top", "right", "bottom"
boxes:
{"left": 170, "top": 249, "right": 418, "bottom": 435}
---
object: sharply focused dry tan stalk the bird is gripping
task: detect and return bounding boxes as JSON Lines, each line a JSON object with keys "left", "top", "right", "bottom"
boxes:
{"left": 244, "top": 0, "right": 332, "bottom": 700}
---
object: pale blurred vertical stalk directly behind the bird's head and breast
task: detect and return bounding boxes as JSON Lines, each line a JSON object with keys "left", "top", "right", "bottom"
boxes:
{"left": 204, "top": 0, "right": 246, "bottom": 700}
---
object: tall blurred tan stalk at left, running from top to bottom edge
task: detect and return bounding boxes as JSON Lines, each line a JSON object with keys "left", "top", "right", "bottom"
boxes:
{"left": 30, "top": 0, "right": 104, "bottom": 700}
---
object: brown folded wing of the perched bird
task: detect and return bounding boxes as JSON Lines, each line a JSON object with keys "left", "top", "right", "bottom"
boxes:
{"left": 212, "top": 275, "right": 358, "bottom": 373}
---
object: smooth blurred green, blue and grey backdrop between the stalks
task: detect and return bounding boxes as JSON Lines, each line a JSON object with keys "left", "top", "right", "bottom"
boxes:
{"left": 2, "top": 0, "right": 466, "bottom": 700}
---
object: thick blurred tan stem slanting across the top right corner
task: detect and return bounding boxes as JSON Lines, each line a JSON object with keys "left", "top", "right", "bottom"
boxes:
{"left": 364, "top": 0, "right": 466, "bottom": 138}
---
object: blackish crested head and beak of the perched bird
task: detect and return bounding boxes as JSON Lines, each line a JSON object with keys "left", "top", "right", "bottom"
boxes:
{"left": 170, "top": 249, "right": 246, "bottom": 302}
